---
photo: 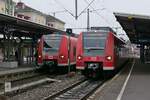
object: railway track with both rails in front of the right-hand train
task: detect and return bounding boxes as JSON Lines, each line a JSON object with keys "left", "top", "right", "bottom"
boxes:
{"left": 42, "top": 80, "right": 105, "bottom": 100}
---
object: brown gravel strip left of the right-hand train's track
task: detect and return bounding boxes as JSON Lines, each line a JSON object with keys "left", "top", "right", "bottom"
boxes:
{"left": 9, "top": 74, "right": 83, "bottom": 100}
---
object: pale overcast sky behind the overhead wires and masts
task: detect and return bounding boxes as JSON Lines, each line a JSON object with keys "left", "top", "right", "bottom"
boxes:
{"left": 14, "top": 0, "right": 150, "bottom": 40}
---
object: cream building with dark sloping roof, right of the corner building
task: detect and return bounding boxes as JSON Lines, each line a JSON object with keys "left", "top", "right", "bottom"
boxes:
{"left": 15, "top": 2, "right": 65, "bottom": 30}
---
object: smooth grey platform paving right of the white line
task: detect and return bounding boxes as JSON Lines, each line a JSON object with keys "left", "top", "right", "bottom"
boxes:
{"left": 121, "top": 60, "right": 150, "bottom": 100}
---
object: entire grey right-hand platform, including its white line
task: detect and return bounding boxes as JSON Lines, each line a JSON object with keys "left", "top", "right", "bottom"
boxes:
{"left": 89, "top": 59, "right": 150, "bottom": 100}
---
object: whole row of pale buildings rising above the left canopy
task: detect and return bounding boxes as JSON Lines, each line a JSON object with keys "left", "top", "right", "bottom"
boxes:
{"left": 0, "top": 0, "right": 65, "bottom": 30}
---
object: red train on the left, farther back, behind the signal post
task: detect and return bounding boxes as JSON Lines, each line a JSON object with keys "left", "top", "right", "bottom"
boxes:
{"left": 37, "top": 32, "right": 77, "bottom": 71}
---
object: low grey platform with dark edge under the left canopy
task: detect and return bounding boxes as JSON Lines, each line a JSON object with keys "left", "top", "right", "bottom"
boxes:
{"left": 0, "top": 65, "right": 39, "bottom": 84}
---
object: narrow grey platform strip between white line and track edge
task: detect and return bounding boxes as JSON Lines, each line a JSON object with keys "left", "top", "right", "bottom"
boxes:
{"left": 89, "top": 59, "right": 132, "bottom": 100}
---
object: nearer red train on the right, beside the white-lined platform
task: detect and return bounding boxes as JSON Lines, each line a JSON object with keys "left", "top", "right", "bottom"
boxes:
{"left": 76, "top": 27, "right": 126, "bottom": 78}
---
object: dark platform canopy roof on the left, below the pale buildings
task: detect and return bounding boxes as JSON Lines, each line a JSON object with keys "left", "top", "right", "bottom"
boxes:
{"left": 0, "top": 14, "right": 61, "bottom": 37}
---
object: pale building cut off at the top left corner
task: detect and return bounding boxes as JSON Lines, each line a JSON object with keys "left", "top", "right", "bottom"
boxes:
{"left": 0, "top": 0, "right": 15, "bottom": 16}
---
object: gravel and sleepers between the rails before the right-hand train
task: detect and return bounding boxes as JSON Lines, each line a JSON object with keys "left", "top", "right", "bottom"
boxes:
{"left": 52, "top": 80, "right": 103, "bottom": 100}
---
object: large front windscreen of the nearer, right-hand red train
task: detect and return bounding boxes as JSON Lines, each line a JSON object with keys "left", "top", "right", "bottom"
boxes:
{"left": 83, "top": 32, "right": 107, "bottom": 56}
